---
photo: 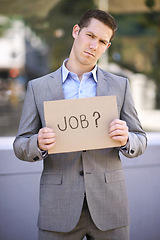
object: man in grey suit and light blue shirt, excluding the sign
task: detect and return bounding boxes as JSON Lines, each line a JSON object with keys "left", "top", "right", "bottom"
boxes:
{"left": 14, "top": 10, "right": 146, "bottom": 240}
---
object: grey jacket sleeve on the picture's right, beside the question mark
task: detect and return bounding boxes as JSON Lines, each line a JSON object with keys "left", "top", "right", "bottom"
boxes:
{"left": 120, "top": 79, "right": 147, "bottom": 158}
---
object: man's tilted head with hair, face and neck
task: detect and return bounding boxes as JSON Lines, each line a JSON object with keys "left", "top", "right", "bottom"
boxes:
{"left": 67, "top": 10, "right": 117, "bottom": 73}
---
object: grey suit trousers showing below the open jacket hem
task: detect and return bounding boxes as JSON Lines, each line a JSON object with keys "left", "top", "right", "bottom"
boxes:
{"left": 38, "top": 197, "right": 129, "bottom": 240}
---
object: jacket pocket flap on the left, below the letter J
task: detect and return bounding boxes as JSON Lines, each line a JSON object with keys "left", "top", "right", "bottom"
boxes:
{"left": 41, "top": 173, "right": 63, "bottom": 185}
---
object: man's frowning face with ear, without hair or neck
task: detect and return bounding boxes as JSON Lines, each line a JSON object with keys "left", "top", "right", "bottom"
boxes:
{"left": 73, "top": 18, "right": 113, "bottom": 69}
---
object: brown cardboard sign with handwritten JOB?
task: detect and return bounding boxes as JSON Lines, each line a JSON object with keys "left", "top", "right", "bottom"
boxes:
{"left": 44, "top": 96, "right": 120, "bottom": 154}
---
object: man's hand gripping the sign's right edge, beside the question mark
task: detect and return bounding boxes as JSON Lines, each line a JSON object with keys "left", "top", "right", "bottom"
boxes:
{"left": 109, "top": 119, "right": 128, "bottom": 146}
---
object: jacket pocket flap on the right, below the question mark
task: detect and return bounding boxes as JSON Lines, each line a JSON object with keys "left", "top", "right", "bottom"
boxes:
{"left": 104, "top": 170, "right": 125, "bottom": 183}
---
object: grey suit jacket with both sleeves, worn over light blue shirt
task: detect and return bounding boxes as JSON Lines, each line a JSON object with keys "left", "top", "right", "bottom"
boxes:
{"left": 14, "top": 68, "right": 146, "bottom": 232}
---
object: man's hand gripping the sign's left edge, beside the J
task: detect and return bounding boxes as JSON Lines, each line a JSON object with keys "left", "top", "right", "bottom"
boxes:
{"left": 38, "top": 127, "right": 56, "bottom": 151}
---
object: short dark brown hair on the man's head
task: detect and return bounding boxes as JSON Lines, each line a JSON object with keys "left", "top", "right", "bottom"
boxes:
{"left": 78, "top": 9, "right": 117, "bottom": 41}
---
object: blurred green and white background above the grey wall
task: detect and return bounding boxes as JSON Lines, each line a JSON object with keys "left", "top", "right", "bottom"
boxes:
{"left": 0, "top": 0, "right": 160, "bottom": 136}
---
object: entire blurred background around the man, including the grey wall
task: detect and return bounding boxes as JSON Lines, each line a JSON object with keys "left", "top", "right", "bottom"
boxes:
{"left": 0, "top": 0, "right": 160, "bottom": 240}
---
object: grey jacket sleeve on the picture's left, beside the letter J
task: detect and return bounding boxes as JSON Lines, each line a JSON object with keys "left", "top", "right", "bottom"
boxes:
{"left": 13, "top": 81, "right": 43, "bottom": 162}
